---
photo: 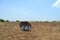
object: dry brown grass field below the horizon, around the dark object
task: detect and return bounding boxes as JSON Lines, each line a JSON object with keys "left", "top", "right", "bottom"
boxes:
{"left": 0, "top": 22, "right": 60, "bottom": 40}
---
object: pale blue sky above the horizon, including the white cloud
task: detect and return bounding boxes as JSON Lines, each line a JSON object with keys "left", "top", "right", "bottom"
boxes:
{"left": 0, "top": 0, "right": 60, "bottom": 21}
